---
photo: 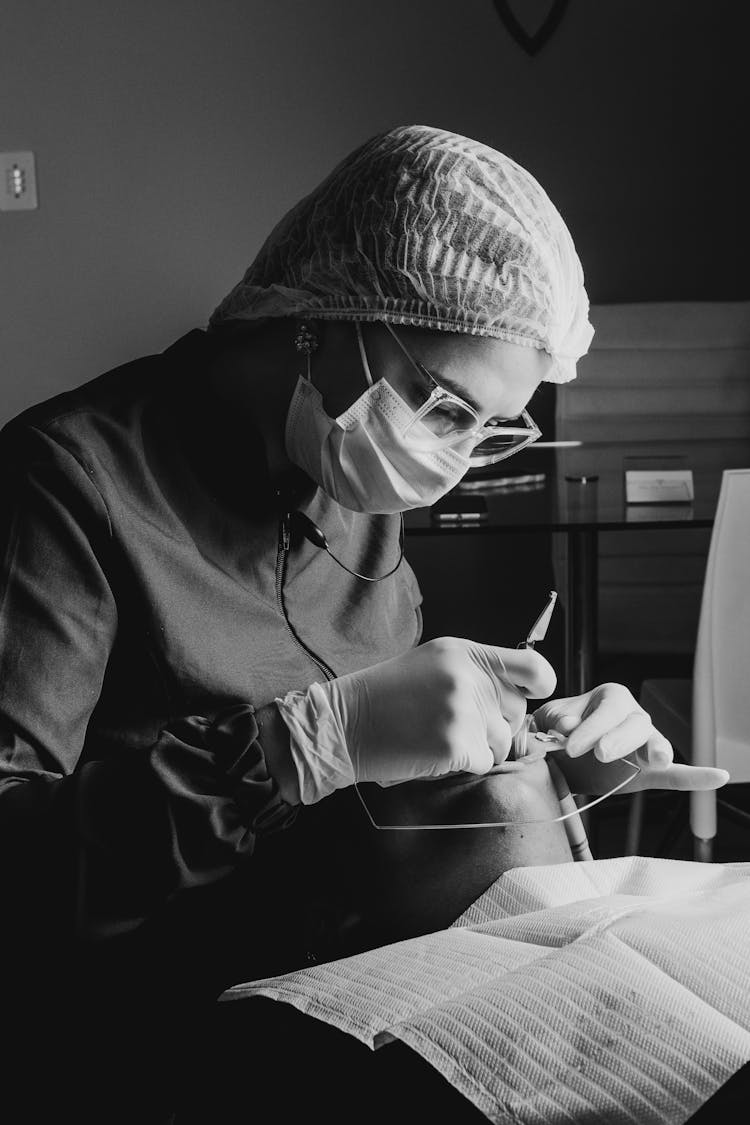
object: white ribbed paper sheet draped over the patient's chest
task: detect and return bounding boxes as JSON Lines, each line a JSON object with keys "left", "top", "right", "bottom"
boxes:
{"left": 223, "top": 856, "right": 750, "bottom": 1125}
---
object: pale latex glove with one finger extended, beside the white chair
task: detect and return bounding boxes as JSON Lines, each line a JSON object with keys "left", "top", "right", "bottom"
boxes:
{"left": 534, "top": 683, "right": 729, "bottom": 794}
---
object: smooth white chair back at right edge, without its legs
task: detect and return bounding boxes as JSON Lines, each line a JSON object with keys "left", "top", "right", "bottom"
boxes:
{"left": 693, "top": 469, "right": 750, "bottom": 782}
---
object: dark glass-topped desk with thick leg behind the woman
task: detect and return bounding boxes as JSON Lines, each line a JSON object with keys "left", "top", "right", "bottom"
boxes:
{"left": 405, "top": 443, "right": 737, "bottom": 695}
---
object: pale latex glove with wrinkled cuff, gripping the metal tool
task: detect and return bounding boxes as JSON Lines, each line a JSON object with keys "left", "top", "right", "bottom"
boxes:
{"left": 275, "top": 637, "right": 557, "bottom": 804}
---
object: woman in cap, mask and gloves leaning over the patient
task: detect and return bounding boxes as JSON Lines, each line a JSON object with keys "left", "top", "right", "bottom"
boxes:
{"left": 0, "top": 126, "right": 725, "bottom": 1122}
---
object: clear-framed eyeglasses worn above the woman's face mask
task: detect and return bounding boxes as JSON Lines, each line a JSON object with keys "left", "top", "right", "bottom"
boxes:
{"left": 385, "top": 322, "right": 542, "bottom": 466}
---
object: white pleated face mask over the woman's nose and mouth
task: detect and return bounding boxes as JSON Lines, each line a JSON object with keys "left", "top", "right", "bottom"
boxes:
{"left": 286, "top": 324, "right": 471, "bottom": 515}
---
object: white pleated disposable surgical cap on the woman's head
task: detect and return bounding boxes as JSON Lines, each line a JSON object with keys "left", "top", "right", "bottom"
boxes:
{"left": 210, "top": 125, "right": 594, "bottom": 383}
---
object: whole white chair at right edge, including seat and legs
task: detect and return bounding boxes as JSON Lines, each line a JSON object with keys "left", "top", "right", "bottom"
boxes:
{"left": 626, "top": 469, "right": 750, "bottom": 863}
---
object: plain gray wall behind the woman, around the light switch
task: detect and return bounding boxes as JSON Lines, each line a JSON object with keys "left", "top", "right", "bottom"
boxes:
{"left": 0, "top": 0, "right": 748, "bottom": 422}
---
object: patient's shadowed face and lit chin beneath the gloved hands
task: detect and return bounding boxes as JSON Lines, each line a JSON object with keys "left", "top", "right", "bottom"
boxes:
{"left": 280, "top": 758, "right": 572, "bottom": 960}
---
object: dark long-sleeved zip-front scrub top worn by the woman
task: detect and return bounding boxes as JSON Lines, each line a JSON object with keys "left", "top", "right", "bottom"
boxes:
{"left": 0, "top": 330, "right": 421, "bottom": 1121}
